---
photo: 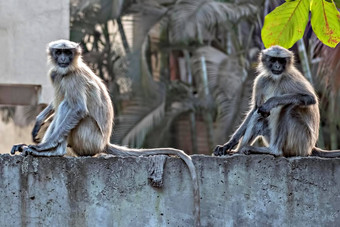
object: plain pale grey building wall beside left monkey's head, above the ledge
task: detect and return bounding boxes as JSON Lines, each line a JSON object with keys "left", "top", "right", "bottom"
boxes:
{"left": 0, "top": 0, "right": 70, "bottom": 103}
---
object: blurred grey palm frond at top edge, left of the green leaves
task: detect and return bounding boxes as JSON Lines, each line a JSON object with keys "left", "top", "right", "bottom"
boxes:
{"left": 169, "top": 0, "right": 257, "bottom": 42}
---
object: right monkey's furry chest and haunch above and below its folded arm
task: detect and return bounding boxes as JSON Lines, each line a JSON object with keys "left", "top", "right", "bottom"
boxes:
{"left": 255, "top": 77, "right": 320, "bottom": 156}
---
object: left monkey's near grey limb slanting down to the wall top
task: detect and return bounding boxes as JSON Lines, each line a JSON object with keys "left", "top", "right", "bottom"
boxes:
{"left": 29, "top": 100, "right": 87, "bottom": 151}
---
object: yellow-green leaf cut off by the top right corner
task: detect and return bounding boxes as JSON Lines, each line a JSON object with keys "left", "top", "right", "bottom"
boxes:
{"left": 311, "top": 0, "right": 340, "bottom": 47}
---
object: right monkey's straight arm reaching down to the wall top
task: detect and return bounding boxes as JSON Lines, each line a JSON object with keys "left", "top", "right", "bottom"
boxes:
{"left": 214, "top": 107, "right": 257, "bottom": 156}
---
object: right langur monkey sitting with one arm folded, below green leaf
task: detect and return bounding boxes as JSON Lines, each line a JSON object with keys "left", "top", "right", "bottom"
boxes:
{"left": 214, "top": 46, "right": 340, "bottom": 158}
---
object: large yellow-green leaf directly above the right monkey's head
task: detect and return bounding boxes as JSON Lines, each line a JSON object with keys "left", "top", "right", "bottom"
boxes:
{"left": 261, "top": 0, "right": 309, "bottom": 48}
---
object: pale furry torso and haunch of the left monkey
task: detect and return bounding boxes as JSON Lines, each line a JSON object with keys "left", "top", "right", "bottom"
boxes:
{"left": 51, "top": 71, "right": 113, "bottom": 154}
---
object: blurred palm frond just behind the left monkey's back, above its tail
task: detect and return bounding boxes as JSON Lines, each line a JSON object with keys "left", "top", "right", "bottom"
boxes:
{"left": 111, "top": 36, "right": 165, "bottom": 147}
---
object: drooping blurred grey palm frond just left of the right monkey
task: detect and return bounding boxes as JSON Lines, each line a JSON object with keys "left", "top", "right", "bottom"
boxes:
{"left": 192, "top": 46, "right": 251, "bottom": 142}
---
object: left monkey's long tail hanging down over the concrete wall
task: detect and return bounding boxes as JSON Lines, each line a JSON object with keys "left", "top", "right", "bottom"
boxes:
{"left": 106, "top": 144, "right": 201, "bottom": 226}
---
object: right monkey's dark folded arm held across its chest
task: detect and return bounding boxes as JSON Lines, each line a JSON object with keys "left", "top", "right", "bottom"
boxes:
{"left": 258, "top": 93, "right": 316, "bottom": 117}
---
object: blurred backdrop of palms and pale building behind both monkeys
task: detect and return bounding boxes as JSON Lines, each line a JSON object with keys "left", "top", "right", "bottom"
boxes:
{"left": 0, "top": 0, "right": 340, "bottom": 155}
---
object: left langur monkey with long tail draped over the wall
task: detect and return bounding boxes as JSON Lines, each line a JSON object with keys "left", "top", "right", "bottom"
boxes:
{"left": 11, "top": 40, "right": 200, "bottom": 226}
